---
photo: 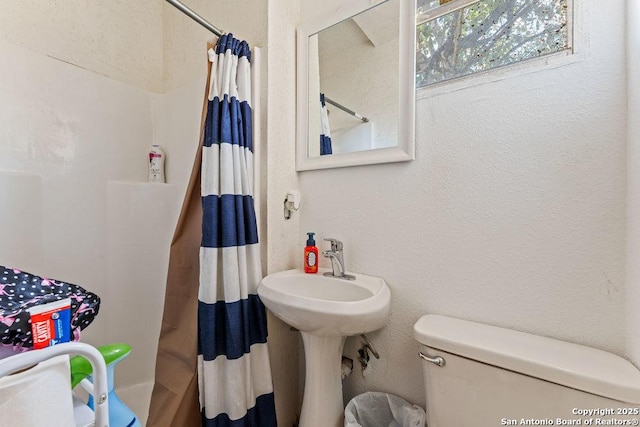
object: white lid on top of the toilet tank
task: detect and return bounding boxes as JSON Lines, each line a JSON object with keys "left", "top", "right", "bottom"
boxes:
{"left": 413, "top": 314, "right": 640, "bottom": 405}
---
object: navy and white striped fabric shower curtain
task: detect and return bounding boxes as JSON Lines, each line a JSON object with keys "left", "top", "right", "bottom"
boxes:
{"left": 198, "top": 34, "right": 276, "bottom": 427}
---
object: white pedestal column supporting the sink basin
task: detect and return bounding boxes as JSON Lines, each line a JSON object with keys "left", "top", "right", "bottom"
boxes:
{"left": 300, "top": 331, "right": 346, "bottom": 427}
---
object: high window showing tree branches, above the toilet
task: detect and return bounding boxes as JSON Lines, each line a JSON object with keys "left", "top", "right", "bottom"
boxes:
{"left": 416, "top": 0, "right": 572, "bottom": 87}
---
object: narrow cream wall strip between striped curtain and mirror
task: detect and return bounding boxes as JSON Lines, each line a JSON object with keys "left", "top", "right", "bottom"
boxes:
{"left": 266, "top": 0, "right": 306, "bottom": 427}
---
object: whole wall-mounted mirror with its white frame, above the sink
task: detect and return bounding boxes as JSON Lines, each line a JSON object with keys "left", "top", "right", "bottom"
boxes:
{"left": 296, "top": 0, "right": 415, "bottom": 171}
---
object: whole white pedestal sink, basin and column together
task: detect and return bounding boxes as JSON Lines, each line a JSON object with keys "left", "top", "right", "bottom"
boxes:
{"left": 258, "top": 269, "right": 391, "bottom": 427}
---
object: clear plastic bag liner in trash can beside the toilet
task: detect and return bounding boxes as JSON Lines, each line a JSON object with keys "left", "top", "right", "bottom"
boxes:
{"left": 344, "top": 391, "right": 427, "bottom": 427}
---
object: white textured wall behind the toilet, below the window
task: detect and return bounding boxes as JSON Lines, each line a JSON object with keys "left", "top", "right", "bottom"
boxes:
{"left": 292, "top": 0, "right": 626, "bottom": 412}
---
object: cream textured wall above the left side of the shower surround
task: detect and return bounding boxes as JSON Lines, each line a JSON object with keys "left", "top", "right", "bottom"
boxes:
{"left": 0, "top": 0, "right": 164, "bottom": 92}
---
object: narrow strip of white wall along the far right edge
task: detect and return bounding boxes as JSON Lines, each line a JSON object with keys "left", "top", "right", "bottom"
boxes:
{"left": 626, "top": 1, "right": 640, "bottom": 366}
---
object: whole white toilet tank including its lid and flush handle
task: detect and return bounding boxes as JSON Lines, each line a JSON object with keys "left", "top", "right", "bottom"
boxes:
{"left": 414, "top": 315, "right": 640, "bottom": 427}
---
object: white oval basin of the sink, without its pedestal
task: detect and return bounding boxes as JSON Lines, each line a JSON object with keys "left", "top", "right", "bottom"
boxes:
{"left": 258, "top": 269, "right": 391, "bottom": 336}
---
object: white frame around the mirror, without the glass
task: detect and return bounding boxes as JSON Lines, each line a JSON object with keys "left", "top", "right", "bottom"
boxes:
{"left": 296, "top": 0, "right": 416, "bottom": 171}
